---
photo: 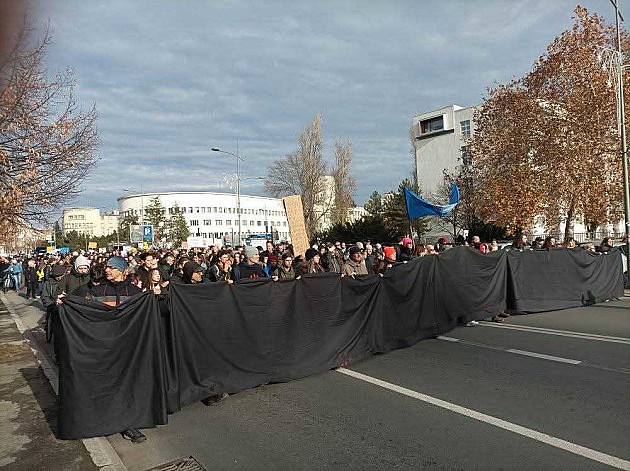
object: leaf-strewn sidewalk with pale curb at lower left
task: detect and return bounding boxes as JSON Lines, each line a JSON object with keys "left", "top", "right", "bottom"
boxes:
{"left": 0, "top": 292, "right": 125, "bottom": 471}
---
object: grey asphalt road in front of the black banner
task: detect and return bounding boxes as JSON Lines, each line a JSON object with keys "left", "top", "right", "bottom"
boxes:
{"left": 109, "top": 298, "right": 630, "bottom": 470}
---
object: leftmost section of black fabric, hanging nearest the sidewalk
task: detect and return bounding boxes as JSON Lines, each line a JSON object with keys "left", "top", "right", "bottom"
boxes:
{"left": 55, "top": 293, "right": 168, "bottom": 439}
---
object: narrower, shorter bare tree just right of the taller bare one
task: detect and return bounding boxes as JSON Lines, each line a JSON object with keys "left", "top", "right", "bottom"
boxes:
{"left": 331, "top": 141, "right": 357, "bottom": 224}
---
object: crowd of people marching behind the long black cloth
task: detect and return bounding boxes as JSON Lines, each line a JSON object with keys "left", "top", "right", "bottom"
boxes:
{"left": 0, "top": 234, "right": 614, "bottom": 443}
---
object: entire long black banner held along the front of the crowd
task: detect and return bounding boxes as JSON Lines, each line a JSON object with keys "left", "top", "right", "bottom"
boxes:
{"left": 58, "top": 247, "right": 623, "bottom": 438}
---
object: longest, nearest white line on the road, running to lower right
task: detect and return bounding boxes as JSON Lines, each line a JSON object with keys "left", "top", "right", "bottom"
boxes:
{"left": 336, "top": 368, "right": 630, "bottom": 470}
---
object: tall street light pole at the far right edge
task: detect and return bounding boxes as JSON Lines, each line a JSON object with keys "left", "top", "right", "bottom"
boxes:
{"left": 611, "top": 0, "right": 630, "bottom": 274}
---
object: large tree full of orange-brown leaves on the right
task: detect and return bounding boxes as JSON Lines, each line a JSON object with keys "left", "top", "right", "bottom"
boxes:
{"left": 468, "top": 7, "right": 628, "bottom": 243}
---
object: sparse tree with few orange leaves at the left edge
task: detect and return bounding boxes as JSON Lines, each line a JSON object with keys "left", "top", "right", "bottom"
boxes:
{"left": 0, "top": 23, "right": 97, "bottom": 240}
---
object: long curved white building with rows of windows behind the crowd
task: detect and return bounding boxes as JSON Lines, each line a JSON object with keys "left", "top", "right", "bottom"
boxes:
{"left": 118, "top": 191, "right": 290, "bottom": 246}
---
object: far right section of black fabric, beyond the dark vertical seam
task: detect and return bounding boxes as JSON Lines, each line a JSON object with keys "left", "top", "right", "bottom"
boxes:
{"left": 507, "top": 248, "right": 623, "bottom": 312}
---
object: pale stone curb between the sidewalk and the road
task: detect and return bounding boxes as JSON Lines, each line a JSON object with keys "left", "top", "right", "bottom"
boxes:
{"left": 0, "top": 292, "right": 127, "bottom": 471}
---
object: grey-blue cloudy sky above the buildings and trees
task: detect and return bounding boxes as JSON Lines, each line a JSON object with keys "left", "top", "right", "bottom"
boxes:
{"left": 36, "top": 0, "right": 616, "bottom": 208}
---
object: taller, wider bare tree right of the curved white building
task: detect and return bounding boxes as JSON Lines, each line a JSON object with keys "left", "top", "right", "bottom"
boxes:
{"left": 265, "top": 114, "right": 330, "bottom": 237}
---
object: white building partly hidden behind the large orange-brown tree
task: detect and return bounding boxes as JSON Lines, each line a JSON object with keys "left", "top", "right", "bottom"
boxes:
{"left": 411, "top": 105, "right": 624, "bottom": 242}
